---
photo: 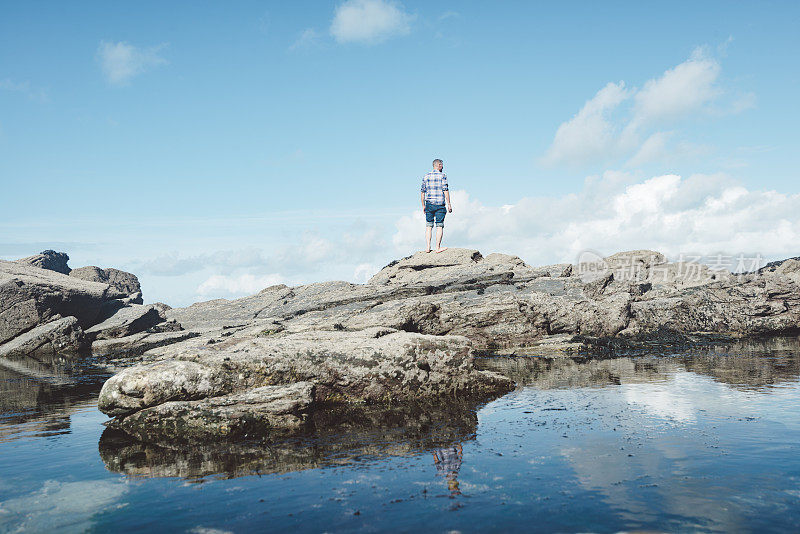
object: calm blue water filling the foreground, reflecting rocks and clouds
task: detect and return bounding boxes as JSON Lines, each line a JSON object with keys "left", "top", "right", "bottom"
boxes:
{"left": 0, "top": 338, "right": 800, "bottom": 532}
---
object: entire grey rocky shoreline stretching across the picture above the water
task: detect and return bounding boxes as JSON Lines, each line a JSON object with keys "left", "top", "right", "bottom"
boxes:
{"left": 0, "top": 249, "right": 800, "bottom": 443}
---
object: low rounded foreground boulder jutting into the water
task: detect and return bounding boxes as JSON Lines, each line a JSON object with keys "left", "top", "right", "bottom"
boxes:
{"left": 98, "top": 328, "right": 513, "bottom": 439}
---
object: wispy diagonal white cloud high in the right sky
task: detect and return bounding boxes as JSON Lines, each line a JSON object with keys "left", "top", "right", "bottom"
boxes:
{"left": 542, "top": 48, "right": 754, "bottom": 171}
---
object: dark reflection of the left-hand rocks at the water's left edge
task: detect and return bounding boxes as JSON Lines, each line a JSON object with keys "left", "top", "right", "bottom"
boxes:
{"left": 0, "top": 355, "right": 111, "bottom": 442}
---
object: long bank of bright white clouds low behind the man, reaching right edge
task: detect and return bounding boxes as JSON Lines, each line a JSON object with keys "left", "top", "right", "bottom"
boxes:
{"left": 393, "top": 178, "right": 800, "bottom": 265}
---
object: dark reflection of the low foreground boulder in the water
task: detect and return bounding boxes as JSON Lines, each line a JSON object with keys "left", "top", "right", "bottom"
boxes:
{"left": 99, "top": 399, "right": 484, "bottom": 487}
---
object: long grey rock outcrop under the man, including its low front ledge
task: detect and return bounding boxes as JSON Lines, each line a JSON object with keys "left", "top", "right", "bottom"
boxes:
{"left": 98, "top": 249, "right": 800, "bottom": 446}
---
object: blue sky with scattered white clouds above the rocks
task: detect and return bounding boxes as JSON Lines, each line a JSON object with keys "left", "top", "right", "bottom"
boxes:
{"left": 0, "top": 0, "right": 800, "bottom": 306}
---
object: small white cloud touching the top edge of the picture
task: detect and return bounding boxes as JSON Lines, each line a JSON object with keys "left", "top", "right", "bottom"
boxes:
{"left": 330, "top": 0, "right": 414, "bottom": 43}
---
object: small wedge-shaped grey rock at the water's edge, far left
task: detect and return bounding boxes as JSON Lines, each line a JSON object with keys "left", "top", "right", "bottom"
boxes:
{"left": 0, "top": 316, "right": 82, "bottom": 357}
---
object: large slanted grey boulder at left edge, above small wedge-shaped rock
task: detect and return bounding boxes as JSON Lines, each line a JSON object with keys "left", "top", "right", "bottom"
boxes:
{"left": 0, "top": 260, "right": 122, "bottom": 343}
